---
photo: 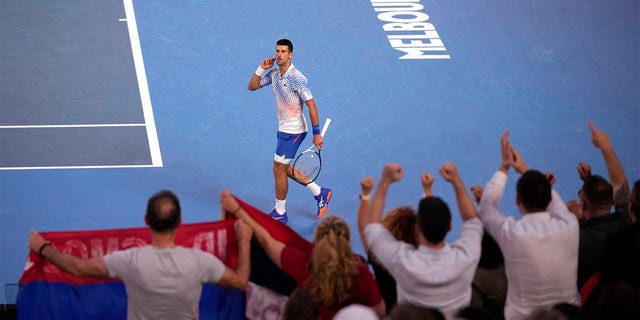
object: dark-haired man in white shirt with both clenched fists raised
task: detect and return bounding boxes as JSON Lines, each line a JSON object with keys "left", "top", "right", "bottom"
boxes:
{"left": 363, "top": 163, "right": 483, "bottom": 319}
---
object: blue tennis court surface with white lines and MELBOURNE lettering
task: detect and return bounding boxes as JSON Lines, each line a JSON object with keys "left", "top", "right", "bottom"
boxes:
{"left": 0, "top": 0, "right": 640, "bottom": 303}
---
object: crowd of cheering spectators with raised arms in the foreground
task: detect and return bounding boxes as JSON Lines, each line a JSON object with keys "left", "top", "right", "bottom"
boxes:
{"left": 29, "top": 122, "right": 640, "bottom": 320}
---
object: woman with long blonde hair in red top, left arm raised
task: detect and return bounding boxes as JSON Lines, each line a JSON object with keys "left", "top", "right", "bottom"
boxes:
{"left": 221, "top": 190, "right": 386, "bottom": 319}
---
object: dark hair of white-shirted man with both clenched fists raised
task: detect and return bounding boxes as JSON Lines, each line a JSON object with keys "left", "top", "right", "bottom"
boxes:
{"left": 418, "top": 197, "right": 451, "bottom": 243}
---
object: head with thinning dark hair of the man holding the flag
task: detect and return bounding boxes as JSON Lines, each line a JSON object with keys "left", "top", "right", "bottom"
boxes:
{"left": 145, "top": 190, "right": 180, "bottom": 233}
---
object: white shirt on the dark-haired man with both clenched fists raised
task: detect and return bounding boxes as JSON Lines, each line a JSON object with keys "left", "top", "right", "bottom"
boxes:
{"left": 364, "top": 218, "right": 483, "bottom": 319}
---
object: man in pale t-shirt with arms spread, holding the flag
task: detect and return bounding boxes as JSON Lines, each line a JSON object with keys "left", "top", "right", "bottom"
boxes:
{"left": 29, "top": 191, "right": 252, "bottom": 320}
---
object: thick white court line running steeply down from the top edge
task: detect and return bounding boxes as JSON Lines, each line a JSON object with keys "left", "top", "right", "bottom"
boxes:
{"left": 121, "top": 0, "right": 162, "bottom": 167}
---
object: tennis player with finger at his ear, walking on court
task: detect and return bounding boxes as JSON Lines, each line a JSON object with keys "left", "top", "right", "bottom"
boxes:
{"left": 247, "top": 39, "right": 332, "bottom": 224}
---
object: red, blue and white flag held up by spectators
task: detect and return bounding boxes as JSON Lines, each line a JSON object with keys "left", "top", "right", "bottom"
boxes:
{"left": 16, "top": 195, "right": 311, "bottom": 320}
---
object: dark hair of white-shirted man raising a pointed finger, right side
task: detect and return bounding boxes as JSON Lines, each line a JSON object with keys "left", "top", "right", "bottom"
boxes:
{"left": 516, "top": 170, "right": 551, "bottom": 212}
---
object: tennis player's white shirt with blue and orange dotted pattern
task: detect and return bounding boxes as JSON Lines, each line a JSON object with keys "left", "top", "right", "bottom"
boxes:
{"left": 260, "top": 63, "right": 313, "bottom": 134}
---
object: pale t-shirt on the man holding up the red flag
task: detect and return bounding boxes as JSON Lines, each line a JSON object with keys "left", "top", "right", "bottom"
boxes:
{"left": 104, "top": 246, "right": 226, "bottom": 320}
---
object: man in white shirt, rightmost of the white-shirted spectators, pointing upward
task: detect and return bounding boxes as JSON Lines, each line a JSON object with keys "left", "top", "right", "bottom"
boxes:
{"left": 479, "top": 132, "right": 580, "bottom": 320}
